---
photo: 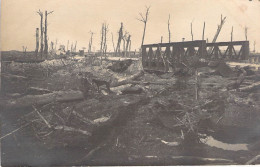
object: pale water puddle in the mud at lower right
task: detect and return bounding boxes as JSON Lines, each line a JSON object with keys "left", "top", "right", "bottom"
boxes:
{"left": 200, "top": 136, "right": 248, "bottom": 151}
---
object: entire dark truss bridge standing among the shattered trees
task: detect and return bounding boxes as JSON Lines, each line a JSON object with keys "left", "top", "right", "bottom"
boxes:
{"left": 142, "top": 40, "right": 249, "bottom": 72}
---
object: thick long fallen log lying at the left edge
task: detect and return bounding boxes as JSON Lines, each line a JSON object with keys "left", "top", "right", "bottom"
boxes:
{"left": 0, "top": 90, "right": 84, "bottom": 109}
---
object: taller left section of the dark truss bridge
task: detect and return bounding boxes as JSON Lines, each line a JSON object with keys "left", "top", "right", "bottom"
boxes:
{"left": 142, "top": 40, "right": 206, "bottom": 72}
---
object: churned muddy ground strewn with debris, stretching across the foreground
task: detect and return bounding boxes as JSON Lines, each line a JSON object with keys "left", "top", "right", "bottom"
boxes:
{"left": 1, "top": 55, "right": 260, "bottom": 166}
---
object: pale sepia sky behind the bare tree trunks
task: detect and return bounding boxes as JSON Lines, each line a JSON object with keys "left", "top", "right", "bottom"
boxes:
{"left": 0, "top": 0, "right": 260, "bottom": 52}
